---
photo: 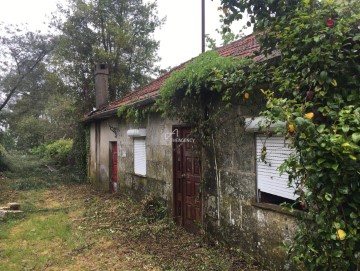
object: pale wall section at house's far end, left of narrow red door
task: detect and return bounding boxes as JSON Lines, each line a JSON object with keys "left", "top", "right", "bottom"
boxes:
{"left": 89, "top": 118, "right": 119, "bottom": 191}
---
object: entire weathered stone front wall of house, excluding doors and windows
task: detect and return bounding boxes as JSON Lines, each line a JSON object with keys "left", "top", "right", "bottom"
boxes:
{"left": 89, "top": 107, "right": 296, "bottom": 270}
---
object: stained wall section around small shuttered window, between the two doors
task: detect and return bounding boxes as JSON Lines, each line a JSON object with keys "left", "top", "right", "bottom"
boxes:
{"left": 119, "top": 113, "right": 175, "bottom": 209}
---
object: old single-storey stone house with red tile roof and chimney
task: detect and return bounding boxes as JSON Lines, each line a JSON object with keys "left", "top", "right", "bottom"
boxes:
{"left": 85, "top": 35, "right": 296, "bottom": 270}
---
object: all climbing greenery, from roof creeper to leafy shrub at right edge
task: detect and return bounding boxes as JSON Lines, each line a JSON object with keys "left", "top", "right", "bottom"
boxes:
{"left": 156, "top": 0, "right": 360, "bottom": 270}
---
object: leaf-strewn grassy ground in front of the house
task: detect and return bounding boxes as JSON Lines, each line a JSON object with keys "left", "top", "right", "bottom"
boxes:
{"left": 0, "top": 156, "right": 264, "bottom": 271}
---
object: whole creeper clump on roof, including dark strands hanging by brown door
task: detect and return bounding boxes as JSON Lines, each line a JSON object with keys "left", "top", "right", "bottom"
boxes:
{"left": 156, "top": 51, "right": 253, "bottom": 144}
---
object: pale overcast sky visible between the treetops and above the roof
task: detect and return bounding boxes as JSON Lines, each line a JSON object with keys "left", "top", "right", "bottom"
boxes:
{"left": 0, "top": 0, "right": 249, "bottom": 68}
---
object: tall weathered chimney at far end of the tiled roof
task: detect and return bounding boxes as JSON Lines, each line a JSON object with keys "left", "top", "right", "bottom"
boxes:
{"left": 95, "top": 64, "right": 109, "bottom": 109}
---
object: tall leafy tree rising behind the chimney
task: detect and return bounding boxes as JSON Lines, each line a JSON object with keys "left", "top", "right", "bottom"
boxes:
{"left": 53, "top": 0, "right": 162, "bottom": 111}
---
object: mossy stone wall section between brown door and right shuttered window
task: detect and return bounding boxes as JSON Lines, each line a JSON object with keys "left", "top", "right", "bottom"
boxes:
{"left": 204, "top": 105, "right": 296, "bottom": 270}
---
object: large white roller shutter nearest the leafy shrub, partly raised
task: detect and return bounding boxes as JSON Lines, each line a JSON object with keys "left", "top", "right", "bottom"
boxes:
{"left": 256, "top": 135, "right": 298, "bottom": 200}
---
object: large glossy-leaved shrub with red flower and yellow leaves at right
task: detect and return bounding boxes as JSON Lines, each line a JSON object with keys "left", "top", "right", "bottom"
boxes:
{"left": 218, "top": 0, "right": 360, "bottom": 270}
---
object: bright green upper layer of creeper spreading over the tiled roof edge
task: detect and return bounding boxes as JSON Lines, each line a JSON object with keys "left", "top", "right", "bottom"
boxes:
{"left": 156, "top": 51, "right": 253, "bottom": 118}
